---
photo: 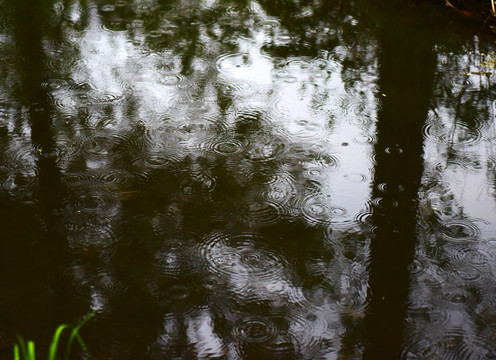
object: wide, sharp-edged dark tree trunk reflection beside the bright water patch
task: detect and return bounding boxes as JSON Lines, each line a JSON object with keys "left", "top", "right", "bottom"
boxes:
{"left": 364, "top": 1, "right": 436, "bottom": 359}
